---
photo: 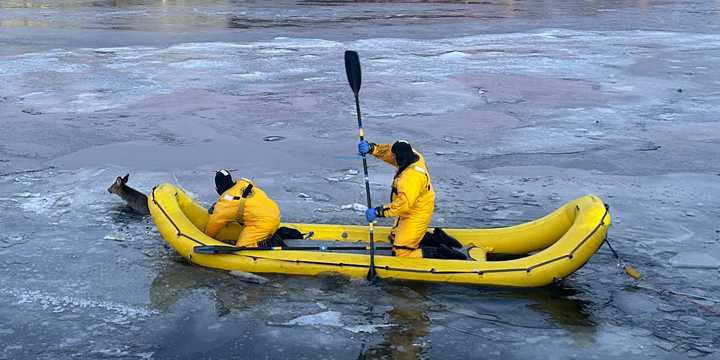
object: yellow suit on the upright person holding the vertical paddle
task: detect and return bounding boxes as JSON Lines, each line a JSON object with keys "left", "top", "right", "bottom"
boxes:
{"left": 372, "top": 144, "right": 435, "bottom": 257}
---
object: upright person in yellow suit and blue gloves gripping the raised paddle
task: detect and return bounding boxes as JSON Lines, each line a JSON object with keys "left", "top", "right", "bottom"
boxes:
{"left": 358, "top": 140, "right": 466, "bottom": 260}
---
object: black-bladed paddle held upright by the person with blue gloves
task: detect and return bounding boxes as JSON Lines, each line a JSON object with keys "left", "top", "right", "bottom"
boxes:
{"left": 345, "top": 50, "right": 377, "bottom": 281}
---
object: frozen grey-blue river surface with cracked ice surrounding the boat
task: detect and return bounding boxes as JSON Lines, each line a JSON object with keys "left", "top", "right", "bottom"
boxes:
{"left": 0, "top": 0, "right": 720, "bottom": 359}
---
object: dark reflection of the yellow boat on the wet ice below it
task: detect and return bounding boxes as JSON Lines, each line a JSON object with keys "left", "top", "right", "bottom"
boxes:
{"left": 149, "top": 256, "right": 598, "bottom": 358}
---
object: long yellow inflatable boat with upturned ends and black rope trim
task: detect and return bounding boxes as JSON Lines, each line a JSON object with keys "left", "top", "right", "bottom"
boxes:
{"left": 148, "top": 184, "right": 610, "bottom": 287}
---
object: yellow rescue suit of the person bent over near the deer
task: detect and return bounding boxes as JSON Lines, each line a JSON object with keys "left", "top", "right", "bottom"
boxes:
{"left": 205, "top": 179, "right": 280, "bottom": 247}
